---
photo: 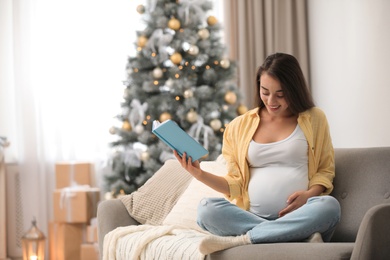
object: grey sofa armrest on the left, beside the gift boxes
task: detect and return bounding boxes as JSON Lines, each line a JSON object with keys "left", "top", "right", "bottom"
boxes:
{"left": 97, "top": 199, "right": 139, "bottom": 256}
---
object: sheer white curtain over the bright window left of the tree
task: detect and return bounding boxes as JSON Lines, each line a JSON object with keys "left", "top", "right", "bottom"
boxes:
{"left": 0, "top": 0, "right": 143, "bottom": 249}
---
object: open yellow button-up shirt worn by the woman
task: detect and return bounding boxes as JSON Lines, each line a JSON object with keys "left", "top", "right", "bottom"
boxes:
{"left": 222, "top": 107, "right": 335, "bottom": 210}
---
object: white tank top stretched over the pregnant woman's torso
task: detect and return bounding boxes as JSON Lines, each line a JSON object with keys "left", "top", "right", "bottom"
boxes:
{"left": 248, "top": 125, "right": 309, "bottom": 219}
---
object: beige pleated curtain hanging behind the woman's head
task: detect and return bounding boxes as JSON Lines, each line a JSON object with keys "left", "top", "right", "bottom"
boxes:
{"left": 225, "top": 0, "right": 310, "bottom": 108}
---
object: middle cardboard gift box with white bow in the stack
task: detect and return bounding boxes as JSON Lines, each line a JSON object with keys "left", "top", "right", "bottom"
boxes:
{"left": 53, "top": 186, "right": 100, "bottom": 223}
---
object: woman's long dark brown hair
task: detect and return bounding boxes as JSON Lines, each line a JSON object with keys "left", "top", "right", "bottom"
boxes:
{"left": 256, "top": 53, "right": 315, "bottom": 114}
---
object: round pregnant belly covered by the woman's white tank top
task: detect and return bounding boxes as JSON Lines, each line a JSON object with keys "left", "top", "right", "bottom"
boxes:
{"left": 248, "top": 167, "right": 309, "bottom": 219}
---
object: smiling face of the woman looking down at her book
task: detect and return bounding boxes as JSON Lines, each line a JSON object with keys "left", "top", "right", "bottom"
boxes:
{"left": 260, "top": 73, "right": 291, "bottom": 116}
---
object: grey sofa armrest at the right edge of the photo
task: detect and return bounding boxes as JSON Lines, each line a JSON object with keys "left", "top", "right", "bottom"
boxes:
{"left": 351, "top": 204, "right": 390, "bottom": 260}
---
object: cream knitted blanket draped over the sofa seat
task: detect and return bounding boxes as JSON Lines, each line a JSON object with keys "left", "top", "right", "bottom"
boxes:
{"left": 103, "top": 225, "right": 208, "bottom": 260}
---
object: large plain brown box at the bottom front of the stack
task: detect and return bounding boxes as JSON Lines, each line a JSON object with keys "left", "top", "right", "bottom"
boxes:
{"left": 49, "top": 222, "right": 85, "bottom": 260}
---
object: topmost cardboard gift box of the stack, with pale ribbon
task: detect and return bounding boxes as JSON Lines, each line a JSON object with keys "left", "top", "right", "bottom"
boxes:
{"left": 55, "top": 162, "right": 94, "bottom": 189}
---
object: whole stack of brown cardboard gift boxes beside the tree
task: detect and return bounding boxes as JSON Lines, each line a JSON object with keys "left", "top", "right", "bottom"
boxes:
{"left": 49, "top": 162, "right": 100, "bottom": 260}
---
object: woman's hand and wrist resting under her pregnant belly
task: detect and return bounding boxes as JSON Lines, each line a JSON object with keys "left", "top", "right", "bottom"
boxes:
{"left": 279, "top": 185, "right": 325, "bottom": 217}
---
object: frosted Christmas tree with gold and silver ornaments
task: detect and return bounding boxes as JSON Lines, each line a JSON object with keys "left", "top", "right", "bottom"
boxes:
{"left": 105, "top": 0, "right": 247, "bottom": 196}
